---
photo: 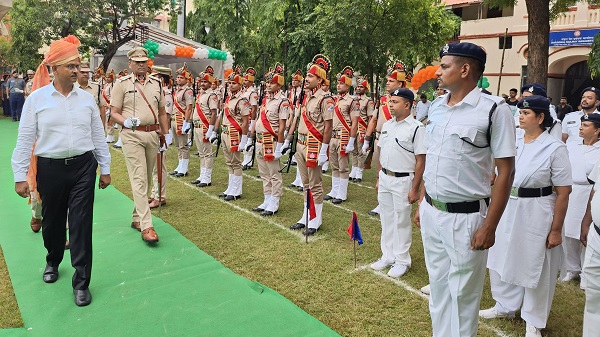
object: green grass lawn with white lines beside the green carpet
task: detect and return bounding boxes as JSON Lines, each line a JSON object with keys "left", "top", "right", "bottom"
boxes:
{"left": 0, "top": 122, "right": 585, "bottom": 337}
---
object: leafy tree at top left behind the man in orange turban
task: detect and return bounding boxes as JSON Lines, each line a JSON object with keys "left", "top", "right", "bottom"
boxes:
{"left": 11, "top": 0, "right": 174, "bottom": 69}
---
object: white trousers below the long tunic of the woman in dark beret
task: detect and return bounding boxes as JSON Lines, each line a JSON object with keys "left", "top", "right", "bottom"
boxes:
{"left": 490, "top": 246, "right": 562, "bottom": 329}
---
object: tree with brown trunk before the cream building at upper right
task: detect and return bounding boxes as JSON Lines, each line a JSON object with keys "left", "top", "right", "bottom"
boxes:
{"left": 484, "top": 0, "right": 600, "bottom": 86}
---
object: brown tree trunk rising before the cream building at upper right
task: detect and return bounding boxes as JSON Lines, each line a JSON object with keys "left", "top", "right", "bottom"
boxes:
{"left": 526, "top": 0, "right": 550, "bottom": 87}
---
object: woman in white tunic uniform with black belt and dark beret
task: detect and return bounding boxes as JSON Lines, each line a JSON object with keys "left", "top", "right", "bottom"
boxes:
{"left": 479, "top": 96, "right": 572, "bottom": 337}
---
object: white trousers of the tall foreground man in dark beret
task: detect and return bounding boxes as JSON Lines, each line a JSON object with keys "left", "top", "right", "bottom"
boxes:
{"left": 419, "top": 200, "right": 488, "bottom": 337}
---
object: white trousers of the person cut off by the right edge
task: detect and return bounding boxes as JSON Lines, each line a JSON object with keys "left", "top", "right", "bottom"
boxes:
{"left": 583, "top": 224, "right": 600, "bottom": 337}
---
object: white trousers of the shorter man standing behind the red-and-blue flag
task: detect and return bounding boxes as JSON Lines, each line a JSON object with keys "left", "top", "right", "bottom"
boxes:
{"left": 377, "top": 171, "right": 413, "bottom": 267}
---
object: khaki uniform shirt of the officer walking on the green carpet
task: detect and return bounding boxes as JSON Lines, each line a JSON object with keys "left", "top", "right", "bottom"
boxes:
{"left": 110, "top": 75, "right": 165, "bottom": 126}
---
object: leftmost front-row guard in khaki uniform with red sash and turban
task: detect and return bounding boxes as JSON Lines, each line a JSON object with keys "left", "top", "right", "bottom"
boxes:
{"left": 169, "top": 65, "right": 194, "bottom": 178}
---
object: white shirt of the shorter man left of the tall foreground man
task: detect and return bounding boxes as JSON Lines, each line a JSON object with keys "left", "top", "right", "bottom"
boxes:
{"left": 377, "top": 116, "right": 427, "bottom": 173}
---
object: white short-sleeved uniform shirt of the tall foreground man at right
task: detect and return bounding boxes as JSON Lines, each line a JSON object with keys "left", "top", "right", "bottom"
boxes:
{"left": 423, "top": 87, "right": 515, "bottom": 202}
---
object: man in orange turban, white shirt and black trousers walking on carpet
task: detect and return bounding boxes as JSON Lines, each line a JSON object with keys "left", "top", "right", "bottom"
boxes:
{"left": 12, "top": 36, "right": 110, "bottom": 306}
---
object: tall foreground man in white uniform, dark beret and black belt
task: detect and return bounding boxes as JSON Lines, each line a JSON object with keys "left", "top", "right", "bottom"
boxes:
{"left": 415, "top": 43, "right": 516, "bottom": 337}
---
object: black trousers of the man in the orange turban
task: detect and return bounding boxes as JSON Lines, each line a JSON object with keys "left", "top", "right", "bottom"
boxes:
{"left": 37, "top": 151, "right": 98, "bottom": 289}
